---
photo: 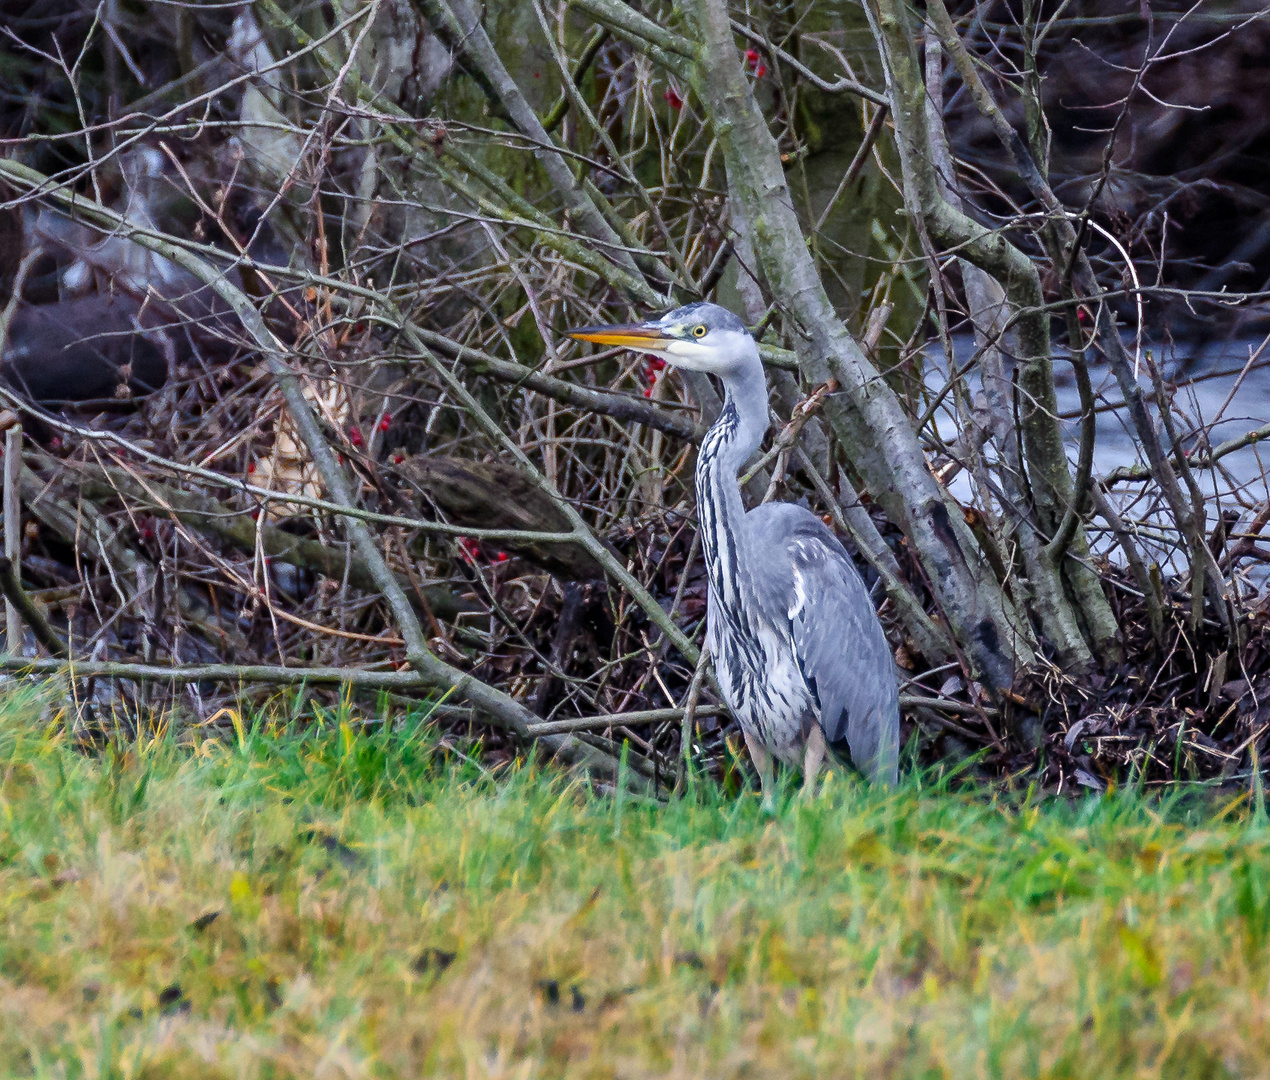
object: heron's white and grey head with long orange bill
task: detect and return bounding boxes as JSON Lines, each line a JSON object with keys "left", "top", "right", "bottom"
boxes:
{"left": 565, "top": 304, "right": 758, "bottom": 375}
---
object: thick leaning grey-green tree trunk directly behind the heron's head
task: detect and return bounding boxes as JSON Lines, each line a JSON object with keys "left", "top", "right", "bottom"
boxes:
{"left": 688, "top": 0, "right": 1034, "bottom": 690}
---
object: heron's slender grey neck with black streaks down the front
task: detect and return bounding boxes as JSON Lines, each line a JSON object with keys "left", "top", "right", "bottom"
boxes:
{"left": 696, "top": 356, "right": 767, "bottom": 607}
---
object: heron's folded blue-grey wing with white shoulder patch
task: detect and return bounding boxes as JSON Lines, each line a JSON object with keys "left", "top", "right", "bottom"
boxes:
{"left": 746, "top": 507, "right": 899, "bottom": 784}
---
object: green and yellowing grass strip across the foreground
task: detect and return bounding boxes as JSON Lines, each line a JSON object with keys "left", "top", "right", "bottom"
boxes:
{"left": 0, "top": 692, "right": 1270, "bottom": 1080}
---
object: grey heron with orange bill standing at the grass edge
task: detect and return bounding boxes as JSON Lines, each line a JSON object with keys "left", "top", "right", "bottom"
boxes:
{"left": 566, "top": 304, "right": 899, "bottom": 808}
